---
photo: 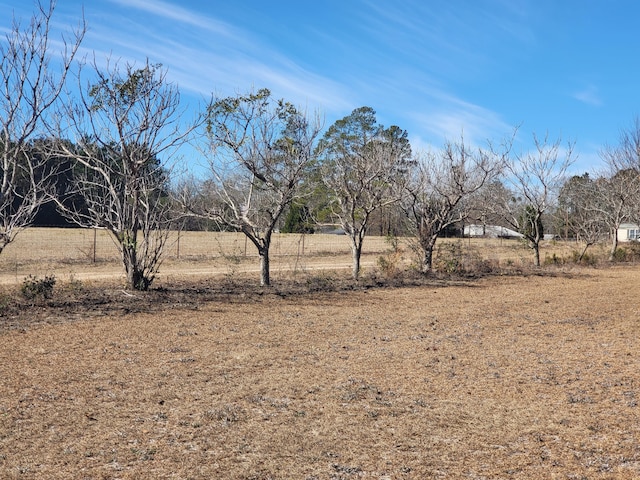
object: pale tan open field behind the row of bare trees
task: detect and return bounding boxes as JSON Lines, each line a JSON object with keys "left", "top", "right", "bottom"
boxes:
{"left": 0, "top": 228, "right": 606, "bottom": 284}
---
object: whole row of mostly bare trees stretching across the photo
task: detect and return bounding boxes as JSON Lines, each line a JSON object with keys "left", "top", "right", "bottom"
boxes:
{"left": 0, "top": 2, "right": 640, "bottom": 290}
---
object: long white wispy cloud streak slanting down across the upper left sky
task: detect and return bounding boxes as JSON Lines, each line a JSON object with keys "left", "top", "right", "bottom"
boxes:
{"left": 79, "top": 0, "right": 350, "bottom": 115}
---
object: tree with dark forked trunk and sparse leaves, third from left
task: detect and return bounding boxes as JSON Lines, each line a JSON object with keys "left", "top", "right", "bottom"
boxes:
{"left": 183, "top": 89, "right": 322, "bottom": 285}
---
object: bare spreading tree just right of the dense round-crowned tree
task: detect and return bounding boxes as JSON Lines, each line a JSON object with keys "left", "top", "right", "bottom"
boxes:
{"left": 403, "top": 138, "right": 509, "bottom": 273}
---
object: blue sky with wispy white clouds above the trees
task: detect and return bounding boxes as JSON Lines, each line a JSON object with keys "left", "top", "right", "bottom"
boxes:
{"left": 0, "top": 0, "right": 640, "bottom": 171}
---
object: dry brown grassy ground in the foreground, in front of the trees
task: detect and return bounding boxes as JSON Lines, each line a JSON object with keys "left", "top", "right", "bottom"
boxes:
{"left": 0, "top": 266, "right": 640, "bottom": 480}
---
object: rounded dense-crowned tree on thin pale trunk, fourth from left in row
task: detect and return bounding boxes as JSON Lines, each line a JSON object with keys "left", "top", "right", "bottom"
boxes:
{"left": 318, "top": 107, "right": 412, "bottom": 280}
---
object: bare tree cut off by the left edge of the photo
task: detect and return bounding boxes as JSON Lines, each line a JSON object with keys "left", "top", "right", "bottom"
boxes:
{"left": 0, "top": 1, "right": 85, "bottom": 252}
